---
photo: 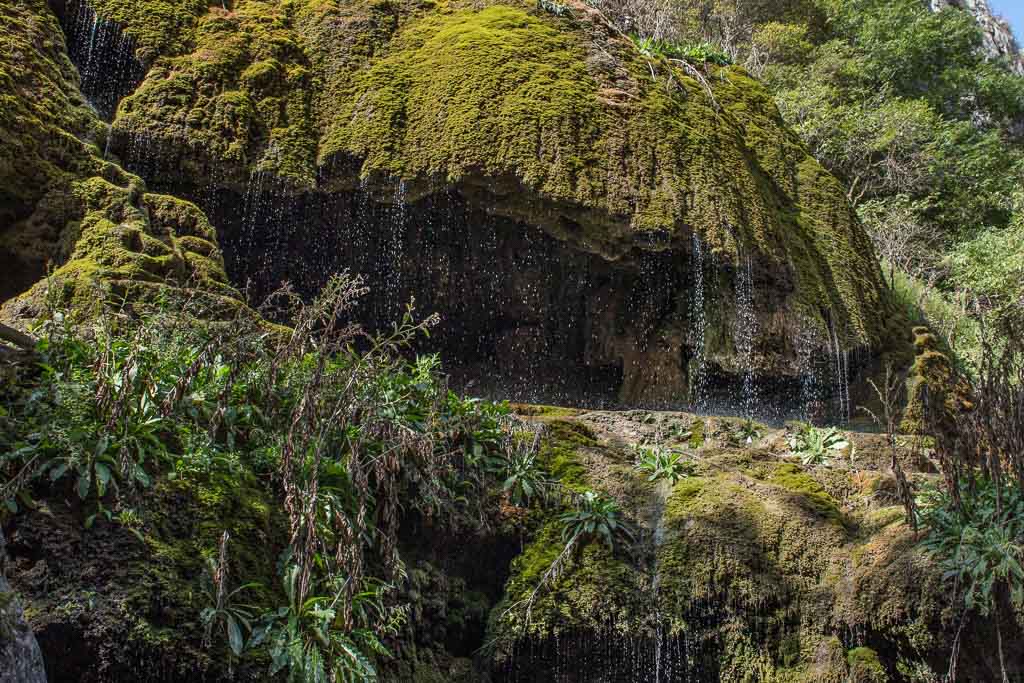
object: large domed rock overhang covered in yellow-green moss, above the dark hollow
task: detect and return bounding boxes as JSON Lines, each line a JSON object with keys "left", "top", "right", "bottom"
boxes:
{"left": 22, "top": 0, "right": 904, "bottom": 402}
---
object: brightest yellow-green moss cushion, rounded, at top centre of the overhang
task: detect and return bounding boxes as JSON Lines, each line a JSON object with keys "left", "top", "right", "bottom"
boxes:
{"left": 323, "top": 6, "right": 600, "bottom": 191}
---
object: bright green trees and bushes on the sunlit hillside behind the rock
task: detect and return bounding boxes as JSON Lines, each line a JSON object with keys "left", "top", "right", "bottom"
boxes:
{"left": 633, "top": 0, "right": 1024, "bottom": 358}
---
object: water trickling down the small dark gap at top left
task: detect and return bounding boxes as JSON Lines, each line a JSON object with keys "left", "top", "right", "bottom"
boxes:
{"left": 63, "top": 0, "right": 144, "bottom": 120}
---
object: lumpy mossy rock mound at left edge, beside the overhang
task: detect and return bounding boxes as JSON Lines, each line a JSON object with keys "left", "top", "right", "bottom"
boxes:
{"left": 0, "top": 0, "right": 238, "bottom": 319}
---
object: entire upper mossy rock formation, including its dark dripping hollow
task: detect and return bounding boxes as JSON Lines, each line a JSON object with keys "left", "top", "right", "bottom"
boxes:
{"left": 6, "top": 0, "right": 905, "bottom": 416}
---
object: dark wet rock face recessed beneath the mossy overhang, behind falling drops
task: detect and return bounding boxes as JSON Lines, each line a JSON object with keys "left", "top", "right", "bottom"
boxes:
{"left": 182, "top": 178, "right": 847, "bottom": 413}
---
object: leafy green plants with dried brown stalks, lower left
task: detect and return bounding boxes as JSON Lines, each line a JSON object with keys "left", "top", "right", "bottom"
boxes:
{"left": 0, "top": 275, "right": 524, "bottom": 680}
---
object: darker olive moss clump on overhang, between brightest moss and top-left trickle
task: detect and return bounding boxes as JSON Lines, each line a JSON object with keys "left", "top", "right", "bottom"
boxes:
{"left": 112, "top": 0, "right": 316, "bottom": 188}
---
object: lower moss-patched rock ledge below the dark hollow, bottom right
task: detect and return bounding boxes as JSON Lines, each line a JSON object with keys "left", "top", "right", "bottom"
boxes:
{"left": 489, "top": 411, "right": 1024, "bottom": 683}
